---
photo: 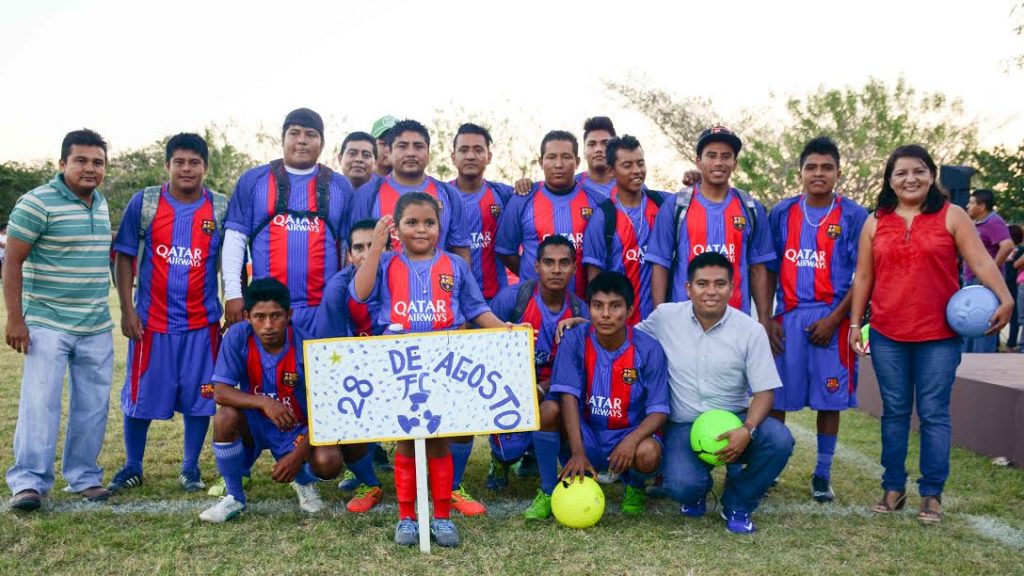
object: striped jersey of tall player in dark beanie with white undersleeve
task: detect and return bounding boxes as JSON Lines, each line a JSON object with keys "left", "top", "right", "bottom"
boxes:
{"left": 225, "top": 165, "right": 352, "bottom": 307}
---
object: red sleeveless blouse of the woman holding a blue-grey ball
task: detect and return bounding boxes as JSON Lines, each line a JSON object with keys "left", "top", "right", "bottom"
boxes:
{"left": 871, "top": 203, "right": 959, "bottom": 342}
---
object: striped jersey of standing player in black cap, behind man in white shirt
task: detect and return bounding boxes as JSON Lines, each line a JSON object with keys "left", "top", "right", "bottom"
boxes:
{"left": 646, "top": 187, "right": 775, "bottom": 314}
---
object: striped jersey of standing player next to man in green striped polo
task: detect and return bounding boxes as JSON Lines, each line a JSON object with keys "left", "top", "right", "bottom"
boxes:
{"left": 114, "top": 183, "right": 224, "bottom": 334}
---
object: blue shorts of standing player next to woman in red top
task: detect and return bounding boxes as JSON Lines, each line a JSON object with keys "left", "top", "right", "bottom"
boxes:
{"left": 772, "top": 305, "right": 857, "bottom": 412}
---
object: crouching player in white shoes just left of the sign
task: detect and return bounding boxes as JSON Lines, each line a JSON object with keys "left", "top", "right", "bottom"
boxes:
{"left": 199, "top": 279, "right": 324, "bottom": 522}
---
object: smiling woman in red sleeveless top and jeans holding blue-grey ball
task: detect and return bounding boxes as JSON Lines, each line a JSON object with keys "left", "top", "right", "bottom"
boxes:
{"left": 850, "top": 145, "right": 1013, "bottom": 523}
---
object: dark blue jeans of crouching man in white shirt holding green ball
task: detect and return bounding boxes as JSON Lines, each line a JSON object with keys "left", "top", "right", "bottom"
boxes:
{"left": 662, "top": 414, "right": 795, "bottom": 512}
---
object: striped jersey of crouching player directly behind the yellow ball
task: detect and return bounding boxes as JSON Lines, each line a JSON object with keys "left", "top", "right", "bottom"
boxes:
{"left": 551, "top": 324, "right": 670, "bottom": 446}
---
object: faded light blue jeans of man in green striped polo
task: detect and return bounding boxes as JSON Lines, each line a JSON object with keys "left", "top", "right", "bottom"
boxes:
{"left": 7, "top": 326, "right": 114, "bottom": 494}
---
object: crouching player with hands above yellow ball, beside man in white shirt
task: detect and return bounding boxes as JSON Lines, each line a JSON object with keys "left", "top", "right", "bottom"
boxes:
{"left": 525, "top": 272, "right": 670, "bottom": 520}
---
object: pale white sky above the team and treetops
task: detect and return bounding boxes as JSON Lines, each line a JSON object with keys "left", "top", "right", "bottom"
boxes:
{"left": 0, "top": 0, "right": 1024, "bottom": 168}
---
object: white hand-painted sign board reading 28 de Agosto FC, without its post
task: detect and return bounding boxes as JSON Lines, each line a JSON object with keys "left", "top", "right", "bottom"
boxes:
{"left": 304, "top": 328, "right": 541, "bottom": 446}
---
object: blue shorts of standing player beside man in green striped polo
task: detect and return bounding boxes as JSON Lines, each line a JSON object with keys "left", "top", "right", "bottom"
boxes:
{"left": 121, "top": 324, "right": 220, "bottom": 420}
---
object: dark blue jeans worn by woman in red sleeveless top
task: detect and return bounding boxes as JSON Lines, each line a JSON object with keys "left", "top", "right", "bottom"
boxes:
{"left": 870, "top": 329, "right": 961, "bottom": 496}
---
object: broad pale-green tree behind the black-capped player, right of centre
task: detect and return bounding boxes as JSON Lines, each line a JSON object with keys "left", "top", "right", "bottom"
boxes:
{"left": 608, "top": 79, "right": 978, "bottom": 205}
